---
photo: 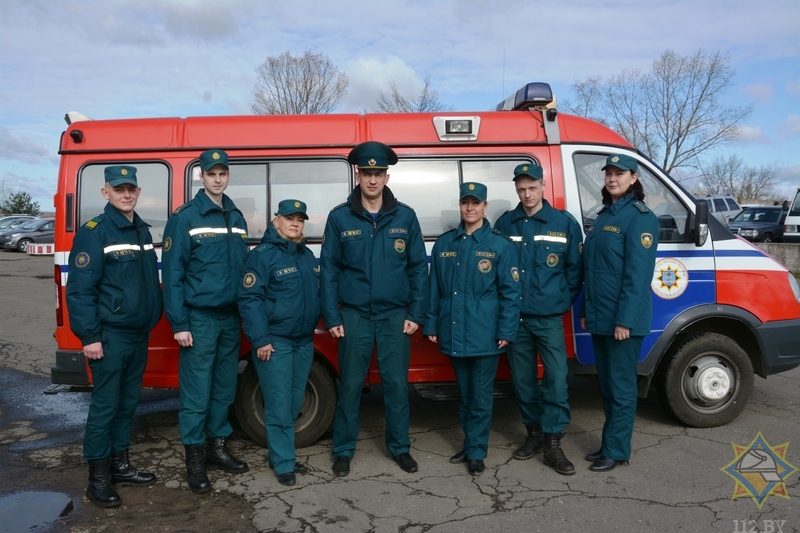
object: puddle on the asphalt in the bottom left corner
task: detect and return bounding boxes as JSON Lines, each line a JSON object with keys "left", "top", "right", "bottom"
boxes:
{"left": 0, "top": 492, "right": 75, "bottom": 533}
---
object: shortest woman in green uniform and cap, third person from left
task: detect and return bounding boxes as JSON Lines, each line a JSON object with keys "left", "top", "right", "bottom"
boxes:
{"left": 239, "top": 200, "right": 320, "bottom": 486}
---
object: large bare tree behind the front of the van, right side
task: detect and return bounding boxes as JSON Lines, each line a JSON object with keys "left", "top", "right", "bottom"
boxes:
{"left": 566, "top": 50, "right": 752, "bottom": 172}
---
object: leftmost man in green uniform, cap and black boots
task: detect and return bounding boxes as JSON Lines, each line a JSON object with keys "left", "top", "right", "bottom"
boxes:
{"left": 67, "top": 165, "right": 162, "bottom": 507}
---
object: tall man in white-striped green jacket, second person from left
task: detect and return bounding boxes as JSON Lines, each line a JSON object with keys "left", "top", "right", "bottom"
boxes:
{"left": 161, "top": 150, "right": 249, "bottom": 494}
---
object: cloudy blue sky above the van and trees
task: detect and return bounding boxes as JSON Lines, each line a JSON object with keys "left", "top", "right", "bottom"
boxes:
{"left": 0, "top": 0, "right": 800, "bottom": 210}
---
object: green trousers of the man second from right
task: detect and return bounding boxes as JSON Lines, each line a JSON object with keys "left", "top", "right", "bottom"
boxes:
{"left": 506, "top": 315, "right": 572, "bottom": 433}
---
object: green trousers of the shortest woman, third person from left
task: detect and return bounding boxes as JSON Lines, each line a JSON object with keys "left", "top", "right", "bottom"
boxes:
{"left": 253, "top": 342, "right": 314, "bottom": 475}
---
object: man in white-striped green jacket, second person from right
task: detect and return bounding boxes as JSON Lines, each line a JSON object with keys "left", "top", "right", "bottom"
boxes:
{"left": 495, "top": 163, "right": 583, "bottom": 475}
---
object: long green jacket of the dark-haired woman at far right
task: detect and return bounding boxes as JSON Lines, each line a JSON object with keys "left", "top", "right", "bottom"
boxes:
{"left": 580, "top": 192, "right": 658, "bottom": 336}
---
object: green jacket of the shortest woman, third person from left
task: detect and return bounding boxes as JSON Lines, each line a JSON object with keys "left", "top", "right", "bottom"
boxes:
{"left": 239, "top": 224, "right": 319, "bottom": 348}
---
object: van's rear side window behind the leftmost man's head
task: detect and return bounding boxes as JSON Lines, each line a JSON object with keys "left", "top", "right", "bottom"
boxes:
{"left": 78, "top": 161, "right": 170, "bottom": 244}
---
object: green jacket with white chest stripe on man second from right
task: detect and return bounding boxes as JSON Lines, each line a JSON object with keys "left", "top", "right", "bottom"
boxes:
{"left": 494, "top": 200, "right": 583, "bottom": 317}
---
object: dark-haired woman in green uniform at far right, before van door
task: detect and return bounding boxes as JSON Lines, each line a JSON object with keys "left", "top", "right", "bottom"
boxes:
{"left": 580, "top": 154, "right": 658, "bottom": 472}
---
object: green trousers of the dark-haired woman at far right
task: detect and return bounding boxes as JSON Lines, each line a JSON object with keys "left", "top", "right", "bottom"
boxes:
{"left": 592, "top": 334, "right": 644, "bottom": 461}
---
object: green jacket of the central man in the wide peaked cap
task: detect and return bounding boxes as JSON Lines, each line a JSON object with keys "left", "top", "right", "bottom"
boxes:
{"left": 320, "top": 187, "right": 428, "bottom": 329}
